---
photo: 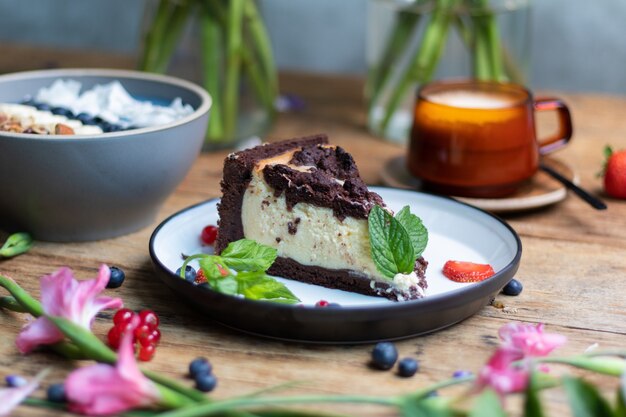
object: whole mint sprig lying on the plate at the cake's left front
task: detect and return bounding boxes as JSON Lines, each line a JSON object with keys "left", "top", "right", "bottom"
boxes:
{"left": 180, "top": 239, "right": 300, "bottom": 304}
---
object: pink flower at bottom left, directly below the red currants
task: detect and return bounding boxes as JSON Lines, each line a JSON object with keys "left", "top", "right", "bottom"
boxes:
{"left": 65, "top": 321, "right": 161, "bottom": 415}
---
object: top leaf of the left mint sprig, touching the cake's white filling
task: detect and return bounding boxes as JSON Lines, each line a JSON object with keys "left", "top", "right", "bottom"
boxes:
{"left": 220, "top": 239, "right": 277, "bottom": 271}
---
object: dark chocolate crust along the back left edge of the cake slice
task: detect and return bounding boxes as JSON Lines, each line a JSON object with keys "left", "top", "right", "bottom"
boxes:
{"left": 215, "top": 134, "right": 328, "bottom": 253}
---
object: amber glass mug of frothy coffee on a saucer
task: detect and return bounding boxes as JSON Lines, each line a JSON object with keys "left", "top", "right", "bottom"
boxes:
{"left": 407, "top": 80, "right": 572, "bottom": 197}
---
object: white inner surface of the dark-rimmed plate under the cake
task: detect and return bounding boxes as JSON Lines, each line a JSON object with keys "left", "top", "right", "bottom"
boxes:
{"left": 153, "top": 187, "right": 520, "bottom": 306}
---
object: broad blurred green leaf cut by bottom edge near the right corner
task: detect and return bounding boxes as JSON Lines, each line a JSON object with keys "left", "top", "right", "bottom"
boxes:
{"left": 563, "top": 376, "right": 614, "bottom": 417}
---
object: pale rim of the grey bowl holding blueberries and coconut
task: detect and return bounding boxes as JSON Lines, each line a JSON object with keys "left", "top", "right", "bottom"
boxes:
{"left": 0, "top": 68, "right": 213, "bottom": 143}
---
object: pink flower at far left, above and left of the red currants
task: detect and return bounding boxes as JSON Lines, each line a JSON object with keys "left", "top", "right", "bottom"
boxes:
{"left": 16, "top": 265, "right": 122, "bottom": 353}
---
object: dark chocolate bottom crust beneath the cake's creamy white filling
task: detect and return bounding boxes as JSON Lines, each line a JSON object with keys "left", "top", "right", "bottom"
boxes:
{"left": 268, "top": 257, "right": 428, "bottom": 301}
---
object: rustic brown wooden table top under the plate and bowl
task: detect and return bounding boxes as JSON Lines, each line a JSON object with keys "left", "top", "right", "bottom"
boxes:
{"left": 0, "top": 74, "right": 626, "bottom": 415}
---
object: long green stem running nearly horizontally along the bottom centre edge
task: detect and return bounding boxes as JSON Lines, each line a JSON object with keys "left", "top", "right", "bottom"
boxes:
{"left": 153, "top": 395, "right": 400, "bottom": 417}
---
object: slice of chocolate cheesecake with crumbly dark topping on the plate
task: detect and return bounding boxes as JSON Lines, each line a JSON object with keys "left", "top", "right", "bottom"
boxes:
{"left": 216, "top": 135, "right": 427, "bottom": 301}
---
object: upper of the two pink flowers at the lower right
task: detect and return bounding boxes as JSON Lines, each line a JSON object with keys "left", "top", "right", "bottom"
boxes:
{"left": 498, "top": 323, "right": 567, "bottom": 357}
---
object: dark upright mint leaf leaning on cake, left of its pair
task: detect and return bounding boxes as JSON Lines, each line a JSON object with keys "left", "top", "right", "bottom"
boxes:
{"left": 368, "top": 206, "right": 415, "bottom": 278}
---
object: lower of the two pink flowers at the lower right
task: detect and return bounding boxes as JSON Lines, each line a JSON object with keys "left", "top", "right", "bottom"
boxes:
{"left": 476, "top": 349, "right": 529, "bottom": 396}
